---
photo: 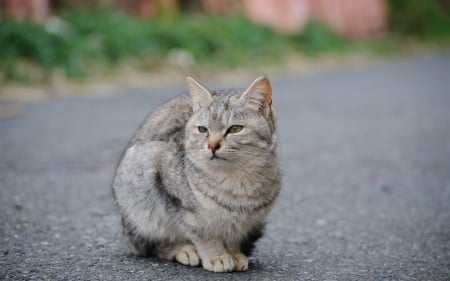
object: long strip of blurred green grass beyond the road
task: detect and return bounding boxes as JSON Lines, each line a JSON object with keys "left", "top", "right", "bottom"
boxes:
{"left": 0, "top": 0, "right": 450, "bottom": 84}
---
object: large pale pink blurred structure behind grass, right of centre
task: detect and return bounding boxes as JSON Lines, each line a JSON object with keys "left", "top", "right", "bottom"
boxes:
{"left": 243, "top": 0, "right": 387, "bottom": 37}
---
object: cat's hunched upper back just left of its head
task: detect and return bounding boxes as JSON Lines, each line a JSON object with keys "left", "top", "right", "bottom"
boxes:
{"left": 130, "top": 95, "right": 192, "bottom": 146}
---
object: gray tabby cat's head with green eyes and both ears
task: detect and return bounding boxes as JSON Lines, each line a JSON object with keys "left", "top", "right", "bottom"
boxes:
{"left": 185, "top": 76, "right": 276, "bottom": 169}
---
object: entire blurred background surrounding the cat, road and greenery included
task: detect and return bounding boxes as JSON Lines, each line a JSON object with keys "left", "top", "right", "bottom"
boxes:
{"left": 0, "top": 0, "right": 450, "bottom": 281}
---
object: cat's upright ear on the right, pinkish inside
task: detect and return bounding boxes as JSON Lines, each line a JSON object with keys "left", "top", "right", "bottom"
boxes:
{"left": 240, "top": 76, "right": 272, "bottom": 118}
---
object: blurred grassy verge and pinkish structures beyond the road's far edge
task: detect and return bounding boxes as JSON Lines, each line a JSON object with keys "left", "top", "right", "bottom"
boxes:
{"left": 0, "top": 0, "right": 450, "bottom": 89}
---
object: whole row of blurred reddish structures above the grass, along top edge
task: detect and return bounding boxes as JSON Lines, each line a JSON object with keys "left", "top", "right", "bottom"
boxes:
{"left": 0, "top": 0, "right": 387, "bottom": 37}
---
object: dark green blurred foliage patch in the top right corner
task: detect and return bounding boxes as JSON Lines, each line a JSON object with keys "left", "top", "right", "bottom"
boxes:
{"left": 388, "top": 0, "right": 450, "bottom": 40}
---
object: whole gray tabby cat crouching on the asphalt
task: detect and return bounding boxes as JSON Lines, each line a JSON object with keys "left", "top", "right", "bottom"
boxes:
{"left": 113, "top": 77, "right": 281, "bottom": 272}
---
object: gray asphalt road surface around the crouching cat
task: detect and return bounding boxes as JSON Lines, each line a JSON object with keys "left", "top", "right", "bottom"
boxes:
{"left": 0, "top": 53, "right": 450, "bottom": 280}
